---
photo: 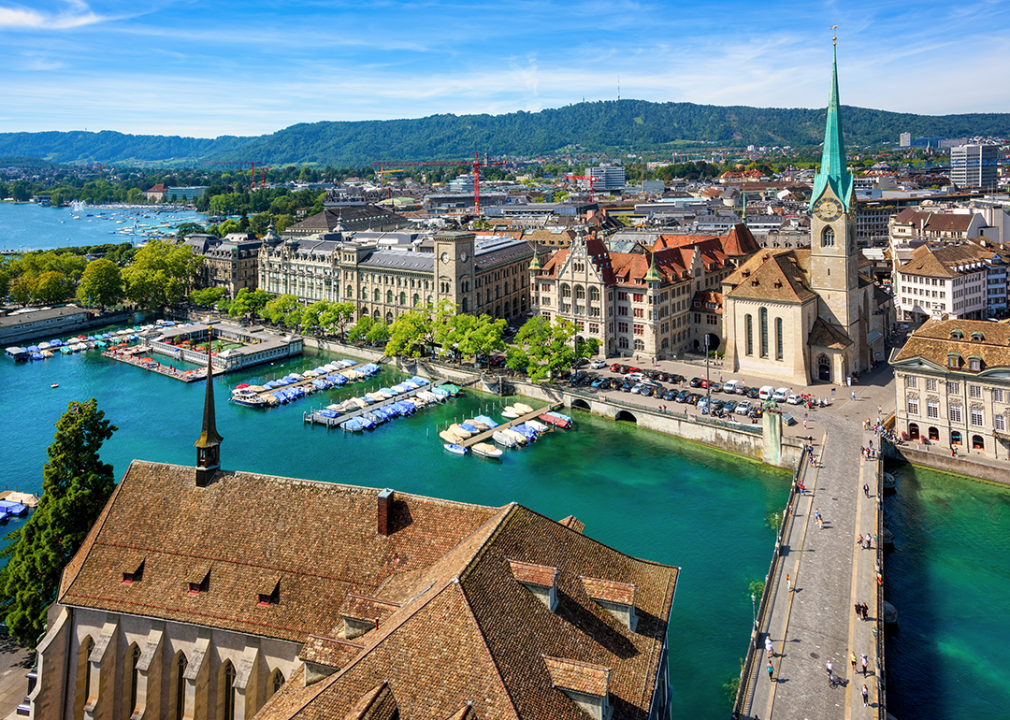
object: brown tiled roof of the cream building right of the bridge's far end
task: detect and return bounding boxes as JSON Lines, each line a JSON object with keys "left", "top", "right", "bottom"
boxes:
{"left": 891, "top": 320, "right": 1010, "bottom": 373}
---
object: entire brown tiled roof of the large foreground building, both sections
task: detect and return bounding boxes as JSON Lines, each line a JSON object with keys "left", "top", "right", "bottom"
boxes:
{"left": 59, "top": 461, "right": 678, "bottom": 720}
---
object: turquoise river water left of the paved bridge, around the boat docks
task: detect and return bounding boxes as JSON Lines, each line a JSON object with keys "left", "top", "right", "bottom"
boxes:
{"left": 0, "top": 333, "right": 789, "bottom": 718}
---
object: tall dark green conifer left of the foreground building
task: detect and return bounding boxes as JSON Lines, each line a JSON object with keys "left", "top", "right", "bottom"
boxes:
{"left": 0, "top": 398, "right": 117, "bottom": 647}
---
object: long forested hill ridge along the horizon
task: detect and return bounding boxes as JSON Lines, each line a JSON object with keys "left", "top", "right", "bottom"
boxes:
{"left": 0, "top": 100, "right": 1010, "bottom": 168}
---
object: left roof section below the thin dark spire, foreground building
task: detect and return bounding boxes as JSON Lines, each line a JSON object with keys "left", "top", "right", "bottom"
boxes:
{"left": 59, "top": 461, "right": 499, "bottom": 642}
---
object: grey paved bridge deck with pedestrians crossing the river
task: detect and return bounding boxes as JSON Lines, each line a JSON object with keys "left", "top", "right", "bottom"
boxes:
{"left": 736, "top": 368, "right": 894, "bottom": 720}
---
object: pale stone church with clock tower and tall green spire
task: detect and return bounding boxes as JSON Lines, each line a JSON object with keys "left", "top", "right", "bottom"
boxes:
{"left": 722, "top": 45, "right": 890, "bottom": 385}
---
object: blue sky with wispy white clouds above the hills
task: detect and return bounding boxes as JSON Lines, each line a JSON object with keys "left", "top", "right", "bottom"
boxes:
{"left": 0, "top": 0, "right": 1010, "bottom": 137}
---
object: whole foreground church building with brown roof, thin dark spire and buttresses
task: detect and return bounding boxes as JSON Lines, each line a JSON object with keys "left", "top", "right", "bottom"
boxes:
{"left": 30, "top": 361, "right": 679, "bottom": 720}
